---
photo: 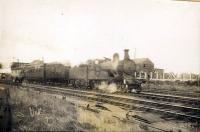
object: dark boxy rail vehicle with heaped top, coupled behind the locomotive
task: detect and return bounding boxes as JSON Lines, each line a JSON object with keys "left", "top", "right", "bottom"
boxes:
{"left": 21, "top": 61, "right": 69, "bottom": 83}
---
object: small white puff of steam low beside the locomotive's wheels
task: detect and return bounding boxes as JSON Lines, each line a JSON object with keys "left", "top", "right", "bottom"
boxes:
{"left": 98, "top": 82, "right": 117, "bottom": 93}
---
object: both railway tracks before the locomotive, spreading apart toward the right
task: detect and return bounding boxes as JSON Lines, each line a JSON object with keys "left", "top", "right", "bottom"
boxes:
{"left": 22, "top": 84, "right": 200, "bottom": 124}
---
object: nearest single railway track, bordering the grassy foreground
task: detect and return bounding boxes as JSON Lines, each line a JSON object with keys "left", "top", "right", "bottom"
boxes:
{"left": 22, "top": 84, "right": 200, "bottom": 123}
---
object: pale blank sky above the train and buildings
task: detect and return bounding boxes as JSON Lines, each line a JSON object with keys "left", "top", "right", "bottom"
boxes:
{"left": 0, "top": 0, "right": 200, "bottom": 73}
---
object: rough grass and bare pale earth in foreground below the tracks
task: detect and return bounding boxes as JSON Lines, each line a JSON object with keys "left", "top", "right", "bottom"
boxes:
{"left": 6, "top": 87, "right": 199, "bottom": 132}
